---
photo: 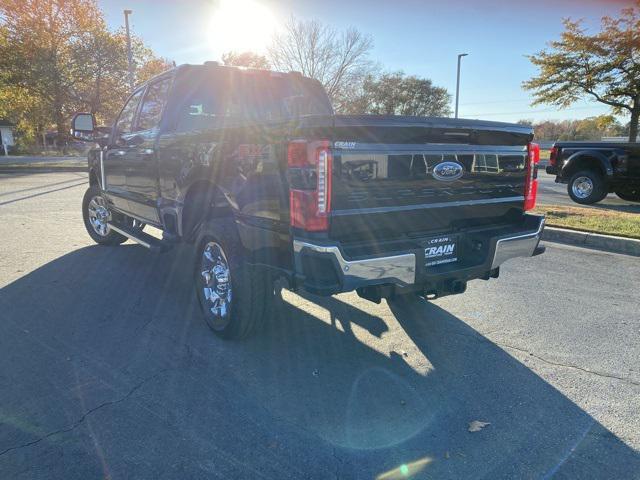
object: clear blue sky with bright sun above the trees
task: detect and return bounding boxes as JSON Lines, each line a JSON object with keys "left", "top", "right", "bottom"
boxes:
{"left": 98, "top": 0, "right": 634, "bottom": 122}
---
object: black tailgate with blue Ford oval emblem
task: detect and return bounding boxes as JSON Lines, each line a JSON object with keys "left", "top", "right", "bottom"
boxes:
{"left": 329, "top": 117, "right": 531, "bottom": 242}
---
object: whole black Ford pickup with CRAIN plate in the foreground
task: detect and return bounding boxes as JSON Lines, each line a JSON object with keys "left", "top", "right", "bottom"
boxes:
{"left": 72, "top": 62, "right": 544, "bottom": 338}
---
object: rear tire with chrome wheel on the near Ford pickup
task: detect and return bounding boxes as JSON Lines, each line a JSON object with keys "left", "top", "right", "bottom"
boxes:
{"left": 194, "top": 218, "right": 273, "bottom": 340}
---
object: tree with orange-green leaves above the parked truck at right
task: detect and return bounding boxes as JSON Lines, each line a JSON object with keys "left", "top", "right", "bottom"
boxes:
{"left": 523, "top": 3, "right": 640, "bottom": 141}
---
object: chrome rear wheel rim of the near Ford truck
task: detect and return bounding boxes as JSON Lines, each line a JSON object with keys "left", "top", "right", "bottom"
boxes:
{"left": 200, "top": 242, "right": 232, "bottom": 323}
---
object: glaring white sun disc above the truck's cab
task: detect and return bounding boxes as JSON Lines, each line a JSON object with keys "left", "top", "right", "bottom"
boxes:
{"left": 209, "top": 0, "right": 276, "bottom": 54}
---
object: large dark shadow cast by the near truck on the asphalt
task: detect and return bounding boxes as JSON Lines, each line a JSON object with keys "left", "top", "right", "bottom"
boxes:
{"left": 0, "top": 245, "right": 640, "bottom": 479}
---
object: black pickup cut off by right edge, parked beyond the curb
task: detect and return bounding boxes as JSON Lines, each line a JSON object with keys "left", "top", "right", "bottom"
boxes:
{"left": 546, "top": 142, "right": 640, "bottom": 205}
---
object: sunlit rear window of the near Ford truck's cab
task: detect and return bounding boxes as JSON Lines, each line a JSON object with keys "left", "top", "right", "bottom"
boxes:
{"left": 171, "top": 69, "right": 332, "bottom": 131}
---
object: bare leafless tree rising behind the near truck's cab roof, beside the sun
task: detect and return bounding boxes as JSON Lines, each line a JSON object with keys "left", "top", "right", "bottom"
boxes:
{"left": 268, "top": 17, "right": 375, "bottom": 112}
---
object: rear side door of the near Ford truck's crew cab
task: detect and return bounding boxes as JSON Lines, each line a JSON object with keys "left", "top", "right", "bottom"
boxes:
{"left": 126, "top": 76, "right": 171, "bottom": 223}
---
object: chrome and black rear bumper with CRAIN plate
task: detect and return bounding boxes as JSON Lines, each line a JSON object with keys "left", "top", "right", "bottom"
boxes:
{"left": 293, "top": 215, "right": 544, "bottom": 295}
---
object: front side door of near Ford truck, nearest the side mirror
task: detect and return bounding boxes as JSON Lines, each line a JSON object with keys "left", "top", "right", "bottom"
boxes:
{"left": 104, "top": 88, "right": 144, "bottom": 212}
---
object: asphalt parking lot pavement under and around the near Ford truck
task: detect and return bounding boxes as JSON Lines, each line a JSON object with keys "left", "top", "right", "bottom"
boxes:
{"left": 0, "top": 173, "right": 640, "bottom": 479}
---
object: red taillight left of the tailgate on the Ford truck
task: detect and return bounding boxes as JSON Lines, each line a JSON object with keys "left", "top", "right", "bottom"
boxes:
{"left": 287, "top": 140, "right": 332, "bottom": 232}
